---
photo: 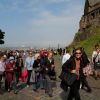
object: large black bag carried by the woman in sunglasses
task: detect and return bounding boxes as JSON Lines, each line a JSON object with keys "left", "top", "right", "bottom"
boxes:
{"left": 59, "top": 72, "right": 77, "bottom": 86}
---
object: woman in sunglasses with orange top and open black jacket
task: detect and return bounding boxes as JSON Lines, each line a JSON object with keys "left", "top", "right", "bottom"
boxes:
{"left": 62, "top": 48, "right": 88, "bottom": 100}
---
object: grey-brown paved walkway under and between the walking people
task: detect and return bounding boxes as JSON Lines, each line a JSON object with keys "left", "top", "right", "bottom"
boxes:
{"left": 0, "top": 57, "right": 100, "bottom": 100}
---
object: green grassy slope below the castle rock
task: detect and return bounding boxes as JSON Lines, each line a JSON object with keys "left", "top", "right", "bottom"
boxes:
{"left": 72, "top": 27, "right": 100, "bottom": 55}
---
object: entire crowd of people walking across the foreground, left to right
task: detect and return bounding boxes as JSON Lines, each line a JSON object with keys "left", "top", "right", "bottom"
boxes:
{"left": 0, "top": 44, "right": 100, "bottom": 100}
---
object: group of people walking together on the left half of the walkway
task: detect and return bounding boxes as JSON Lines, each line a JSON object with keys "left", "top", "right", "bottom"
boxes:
{"left": 0, "top": 50, "right": 56, "bottom": 97}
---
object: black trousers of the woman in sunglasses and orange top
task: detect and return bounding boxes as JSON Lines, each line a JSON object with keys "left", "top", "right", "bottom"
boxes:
{"left": 67, "top": 80, "right": 81, "bottom": 100}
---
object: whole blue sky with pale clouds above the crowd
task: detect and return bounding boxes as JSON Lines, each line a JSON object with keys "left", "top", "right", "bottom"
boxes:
{"left": 0, "top": 0, "right": 85, "bottom": 47}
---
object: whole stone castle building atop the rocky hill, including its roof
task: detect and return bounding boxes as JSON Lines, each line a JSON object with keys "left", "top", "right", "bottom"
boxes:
{"left": 79, "top": 0, "right": 100, "bottom": 31}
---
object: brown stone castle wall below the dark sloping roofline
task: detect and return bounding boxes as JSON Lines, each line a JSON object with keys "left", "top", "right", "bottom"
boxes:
{"left": 80, "top": 3, "right": 100, "bottom": 30}
